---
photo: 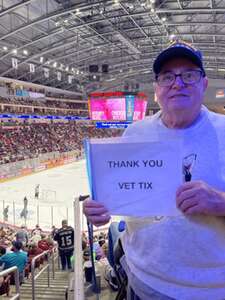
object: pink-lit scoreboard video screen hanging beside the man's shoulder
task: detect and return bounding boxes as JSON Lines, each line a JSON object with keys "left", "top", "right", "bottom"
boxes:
{"left": 89, "top": 95, "right": 147, "bottom": 121}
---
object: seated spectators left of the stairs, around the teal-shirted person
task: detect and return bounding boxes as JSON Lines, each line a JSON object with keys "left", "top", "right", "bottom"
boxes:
{"left": 0, "top": 225, "right": 55, "bottom": 295}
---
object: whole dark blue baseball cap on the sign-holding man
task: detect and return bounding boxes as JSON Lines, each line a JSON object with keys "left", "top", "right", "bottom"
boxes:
{"left": 153, "top": 41, "right": 205, "bottom": 76}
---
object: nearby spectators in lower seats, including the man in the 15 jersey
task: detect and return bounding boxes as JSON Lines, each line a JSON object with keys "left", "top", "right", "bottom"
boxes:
{"left": 0, "top": 220, "right": 111, "bottom": 295}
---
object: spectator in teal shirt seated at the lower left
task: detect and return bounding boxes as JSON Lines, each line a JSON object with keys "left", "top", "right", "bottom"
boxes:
{"left": 0, "top": 241, "right": 27, "bottom": 283}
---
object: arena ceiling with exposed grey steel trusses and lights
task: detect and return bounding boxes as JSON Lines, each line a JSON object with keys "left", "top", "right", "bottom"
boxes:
{"left": 0, "top": 0, "right": 225, "bottom": 98}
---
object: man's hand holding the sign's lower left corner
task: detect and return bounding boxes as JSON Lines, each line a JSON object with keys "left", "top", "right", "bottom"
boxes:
{"left": 83, "top": 198, "right": 111, "bottom": 226}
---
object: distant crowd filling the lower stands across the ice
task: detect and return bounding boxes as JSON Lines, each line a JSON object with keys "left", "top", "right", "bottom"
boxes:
{"left": 0, "top": 122, "right": 119, "bottom": 164}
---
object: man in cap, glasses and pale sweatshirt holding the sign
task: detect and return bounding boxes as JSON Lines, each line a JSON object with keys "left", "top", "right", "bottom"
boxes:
{"left": 84, "top": 42, "right": 225, "bottom": 300}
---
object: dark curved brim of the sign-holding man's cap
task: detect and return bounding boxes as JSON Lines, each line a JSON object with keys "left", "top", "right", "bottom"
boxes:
{"left": 153, "top": 47, "right": 203, "bottom": 74}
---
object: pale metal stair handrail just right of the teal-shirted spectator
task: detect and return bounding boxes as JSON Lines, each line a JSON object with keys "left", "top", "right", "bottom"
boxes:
{"left": 31, "top": 250, "right": 50, "bottom": 300}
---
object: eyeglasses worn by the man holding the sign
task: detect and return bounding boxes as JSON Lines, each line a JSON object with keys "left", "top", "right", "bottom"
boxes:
{"left": 156, "top": 70, "right": 204, "bottom": 87}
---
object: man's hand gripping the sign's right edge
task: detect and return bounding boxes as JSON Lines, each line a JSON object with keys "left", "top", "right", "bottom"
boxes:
{"left": 176, "top": 181, "right": 225, "bottom": 216}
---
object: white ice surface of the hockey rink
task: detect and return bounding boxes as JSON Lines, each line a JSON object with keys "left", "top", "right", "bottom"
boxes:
{"left": 0, "top": 160, "right": 89, "bottom": 229}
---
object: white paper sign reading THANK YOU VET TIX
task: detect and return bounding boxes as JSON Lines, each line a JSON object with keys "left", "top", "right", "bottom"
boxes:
{"left": 85, "top": 138, "right": 182, "bottom": 216}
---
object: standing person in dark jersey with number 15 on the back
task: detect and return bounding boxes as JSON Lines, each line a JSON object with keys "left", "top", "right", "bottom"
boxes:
{"left": 54, "top": 220, "right": 74, "bottom": 270}
